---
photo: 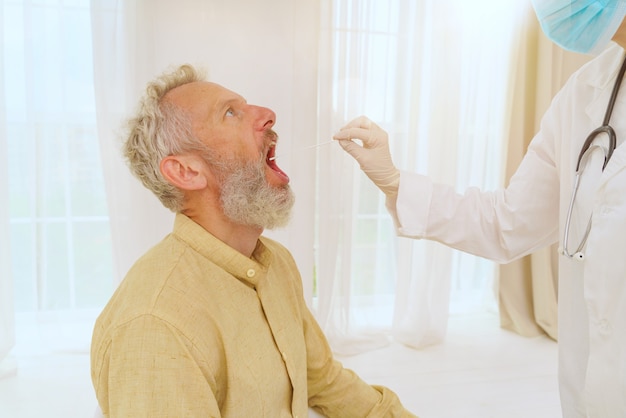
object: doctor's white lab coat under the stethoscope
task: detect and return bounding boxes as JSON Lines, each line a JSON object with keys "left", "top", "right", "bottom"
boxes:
{"left": 388, "top": 44, "right": 626, "bottom": 418}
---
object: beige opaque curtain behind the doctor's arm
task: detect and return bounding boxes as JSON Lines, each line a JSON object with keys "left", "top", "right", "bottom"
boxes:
{"left": 498, "top": 6, "right": 589, "bottom": 340}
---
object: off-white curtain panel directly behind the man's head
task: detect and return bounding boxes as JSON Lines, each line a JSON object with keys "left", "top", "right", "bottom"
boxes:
{"left": 92, "top": 0, "right": 319, "bottom": 296}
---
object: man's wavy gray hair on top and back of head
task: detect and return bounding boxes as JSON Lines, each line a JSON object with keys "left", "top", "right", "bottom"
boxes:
{"left": 123, "top": 64, "right": 206, "bottom": 212}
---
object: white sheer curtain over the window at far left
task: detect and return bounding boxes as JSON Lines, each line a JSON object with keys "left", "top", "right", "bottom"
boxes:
{"left": 0, "top": 0, "right": 112, "bottom": 363}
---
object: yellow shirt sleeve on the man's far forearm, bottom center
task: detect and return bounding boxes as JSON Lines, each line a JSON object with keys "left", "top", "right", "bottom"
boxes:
{"left": 303, "top": 307, "right": 415, "bottom": 418}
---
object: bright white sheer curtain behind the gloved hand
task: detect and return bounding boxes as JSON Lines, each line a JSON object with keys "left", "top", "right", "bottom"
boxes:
{"left": 317, "top": 0, "right": 527, "bottom": 353}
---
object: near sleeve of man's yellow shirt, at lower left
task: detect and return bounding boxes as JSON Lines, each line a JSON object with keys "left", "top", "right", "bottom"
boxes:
{"left": 94, "top": 315, "right": 220, "bottom": 418}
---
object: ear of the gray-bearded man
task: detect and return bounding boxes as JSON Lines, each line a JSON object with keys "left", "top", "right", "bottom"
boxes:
{"left": 159, "top": 155, "right": 207, "bottom": 190}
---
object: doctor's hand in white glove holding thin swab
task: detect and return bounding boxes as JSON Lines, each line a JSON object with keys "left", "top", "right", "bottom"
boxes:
{"left": 333, "top": 116, "right": 400, "bottom": 196}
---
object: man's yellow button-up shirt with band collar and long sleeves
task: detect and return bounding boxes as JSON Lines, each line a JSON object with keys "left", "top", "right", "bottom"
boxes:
{"left": 91, "top": 214, "right": 413, "bottom": 418}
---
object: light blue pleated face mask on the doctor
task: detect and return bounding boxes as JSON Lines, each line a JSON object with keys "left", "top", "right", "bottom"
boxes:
{"left": 532, "top": 0, "right": 626, "bottom": 55}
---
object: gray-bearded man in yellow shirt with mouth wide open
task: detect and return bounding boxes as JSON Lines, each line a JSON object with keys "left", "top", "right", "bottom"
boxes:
{"left": 91, "top": 65, "right": 413, "bottom": 418}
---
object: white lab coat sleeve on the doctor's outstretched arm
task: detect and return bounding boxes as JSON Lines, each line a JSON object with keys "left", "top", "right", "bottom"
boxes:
{"left": 387, "top": 118, "right": 559, "bottom": 263}
